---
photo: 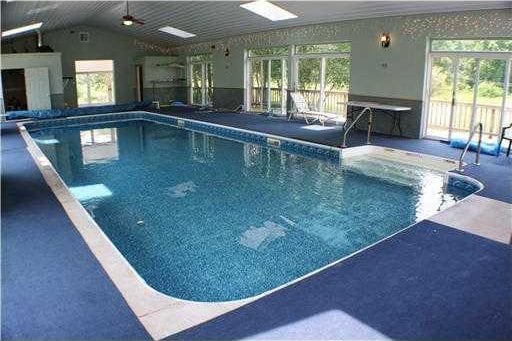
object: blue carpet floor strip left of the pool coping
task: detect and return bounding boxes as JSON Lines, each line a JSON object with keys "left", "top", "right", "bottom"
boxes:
{"left": 1, "top": 124, "right": 149, "bottom": 340}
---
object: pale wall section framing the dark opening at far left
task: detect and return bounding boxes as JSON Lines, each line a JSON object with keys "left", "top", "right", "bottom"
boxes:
{"left": 0, "top": 52, "right": 63, "bottom": 94}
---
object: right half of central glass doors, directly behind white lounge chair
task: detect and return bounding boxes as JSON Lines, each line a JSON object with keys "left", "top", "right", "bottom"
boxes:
{"left": 294, "top": 42, "right": 350, "bottom": 116}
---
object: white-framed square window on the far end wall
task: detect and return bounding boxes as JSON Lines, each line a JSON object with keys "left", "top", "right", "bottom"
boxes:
{"left": 75, "top": 60, "right": 115, "bottom": 106}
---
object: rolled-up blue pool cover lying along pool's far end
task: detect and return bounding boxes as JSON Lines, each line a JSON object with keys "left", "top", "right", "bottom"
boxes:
{"left": 6, "top": 101, "right": 151, "bottom": 120}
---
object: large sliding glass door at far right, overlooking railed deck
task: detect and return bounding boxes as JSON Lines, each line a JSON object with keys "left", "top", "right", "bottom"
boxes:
{"left": 425, "top": 41, "right": 512, "bottom": 141}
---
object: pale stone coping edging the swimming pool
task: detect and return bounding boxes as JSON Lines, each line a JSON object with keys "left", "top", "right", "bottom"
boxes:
{"left": 18, "top": 113, "right": 483, "bottom": 340}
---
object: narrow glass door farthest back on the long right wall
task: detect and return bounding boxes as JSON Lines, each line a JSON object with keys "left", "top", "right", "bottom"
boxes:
{"left": 188, "top": 55, "right": 213, "bottom": 105}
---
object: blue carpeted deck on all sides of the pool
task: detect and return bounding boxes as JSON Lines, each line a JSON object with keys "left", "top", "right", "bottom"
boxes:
{"left": 1, "top": 111, "right": 512, "bottom": 339}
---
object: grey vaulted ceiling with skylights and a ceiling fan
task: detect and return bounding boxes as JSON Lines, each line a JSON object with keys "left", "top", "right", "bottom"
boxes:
{"left": 1, "top": 1, "right": 512, "bottom": 45}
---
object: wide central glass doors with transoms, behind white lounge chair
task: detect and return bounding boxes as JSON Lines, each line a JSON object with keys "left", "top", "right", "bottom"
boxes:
{"left": 245, "top": 42, "right": 350, "bottom": 116}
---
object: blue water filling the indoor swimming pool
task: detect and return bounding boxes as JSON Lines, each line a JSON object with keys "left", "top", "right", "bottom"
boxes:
{"left": 31, "top": 121, "right": 476, "bottom": 301}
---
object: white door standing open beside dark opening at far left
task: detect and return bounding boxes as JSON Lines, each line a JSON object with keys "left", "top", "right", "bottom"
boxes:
{"left": 25, "top": 67, "right": 52, "bottom": 110}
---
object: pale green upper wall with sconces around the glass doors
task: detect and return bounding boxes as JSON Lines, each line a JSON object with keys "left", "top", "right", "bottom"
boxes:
{"left": 175, "top": 9, "right": 512, "bottom": 101}
